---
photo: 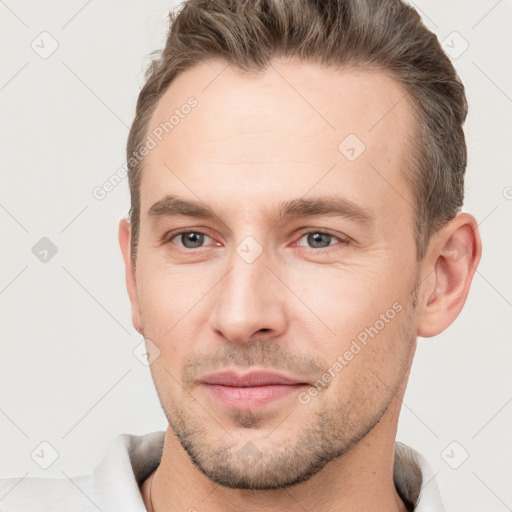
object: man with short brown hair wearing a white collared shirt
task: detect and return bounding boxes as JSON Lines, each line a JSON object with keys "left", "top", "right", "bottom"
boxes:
{"left": 1, "top": 0, "right": 481, "bottom": 512}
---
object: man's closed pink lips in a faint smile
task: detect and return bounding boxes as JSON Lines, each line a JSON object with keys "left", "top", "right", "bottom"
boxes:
{"left": 200, "top": 371, "right": 310, "bottom": 409}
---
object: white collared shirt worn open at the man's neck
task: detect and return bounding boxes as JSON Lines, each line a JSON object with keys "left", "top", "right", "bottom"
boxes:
{"left": 0, "top": 431, "right": 445, "bottom": 512}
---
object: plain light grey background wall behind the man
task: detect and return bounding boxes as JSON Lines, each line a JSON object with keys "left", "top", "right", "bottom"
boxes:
{"left": 0, "top": 0, "right": 512, "bottom": 512}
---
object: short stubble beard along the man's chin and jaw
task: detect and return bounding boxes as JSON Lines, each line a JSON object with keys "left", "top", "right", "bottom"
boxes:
{"left": 152, "top": 280, "right": 419, "bottom": 490}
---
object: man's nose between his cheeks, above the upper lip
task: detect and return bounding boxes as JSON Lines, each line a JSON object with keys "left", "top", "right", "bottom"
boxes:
{"left": 210, "top": 244, "right": 287, "bottom": 343}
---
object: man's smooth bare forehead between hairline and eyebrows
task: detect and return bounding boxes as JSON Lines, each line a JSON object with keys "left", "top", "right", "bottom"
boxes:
{"left": 141, "top": 60, "right": 414, "bottom": 222}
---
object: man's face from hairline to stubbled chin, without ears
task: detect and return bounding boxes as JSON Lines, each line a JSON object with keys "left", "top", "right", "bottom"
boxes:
{"left": 132, "top": 61, "right": 424, "bottom": 489}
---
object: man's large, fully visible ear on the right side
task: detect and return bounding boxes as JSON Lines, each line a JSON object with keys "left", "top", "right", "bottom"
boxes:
{"left": 418, "top": 213, "right": 482, "bottom": 338}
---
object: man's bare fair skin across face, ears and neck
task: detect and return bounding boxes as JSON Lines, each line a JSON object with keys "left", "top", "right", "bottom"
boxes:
{"left": 119, "top": 60, "right": 481, "bottom": 512}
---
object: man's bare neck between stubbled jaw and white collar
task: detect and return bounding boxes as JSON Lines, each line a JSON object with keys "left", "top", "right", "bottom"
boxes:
{"left": 142, "top": 398, "right": 406, "bottom": 512}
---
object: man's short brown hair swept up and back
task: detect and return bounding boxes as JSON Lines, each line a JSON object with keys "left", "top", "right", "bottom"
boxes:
{"left": 126, "top": 0, "right": 467, "bottom": 261}
